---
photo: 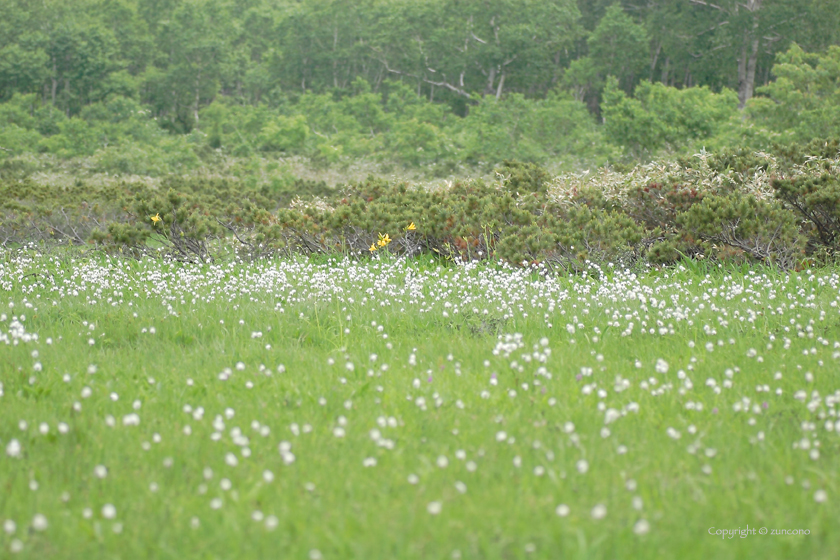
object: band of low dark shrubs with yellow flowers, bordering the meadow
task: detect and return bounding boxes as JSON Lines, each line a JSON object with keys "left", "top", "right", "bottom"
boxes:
{"left": 0, "top": 141, "right": 840, "bottom": 271}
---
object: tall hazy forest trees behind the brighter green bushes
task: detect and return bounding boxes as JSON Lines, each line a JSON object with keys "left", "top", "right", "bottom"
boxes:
{"left": 0, "top": 0, "right": 840, "bottom": 116}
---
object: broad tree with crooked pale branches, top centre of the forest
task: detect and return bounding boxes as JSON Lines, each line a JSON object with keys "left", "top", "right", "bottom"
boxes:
{"left": 374, "top": 0, "right": 581, "bottom": 107}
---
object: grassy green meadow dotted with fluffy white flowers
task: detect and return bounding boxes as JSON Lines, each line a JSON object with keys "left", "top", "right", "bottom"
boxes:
{"left": 0, "top": 252, "right": 840, "bottom": 560}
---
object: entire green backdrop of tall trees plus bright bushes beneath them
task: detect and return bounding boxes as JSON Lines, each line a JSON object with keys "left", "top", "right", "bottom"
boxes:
{"left": 0, "top": 0, "right": 840, "bottom": 178}
